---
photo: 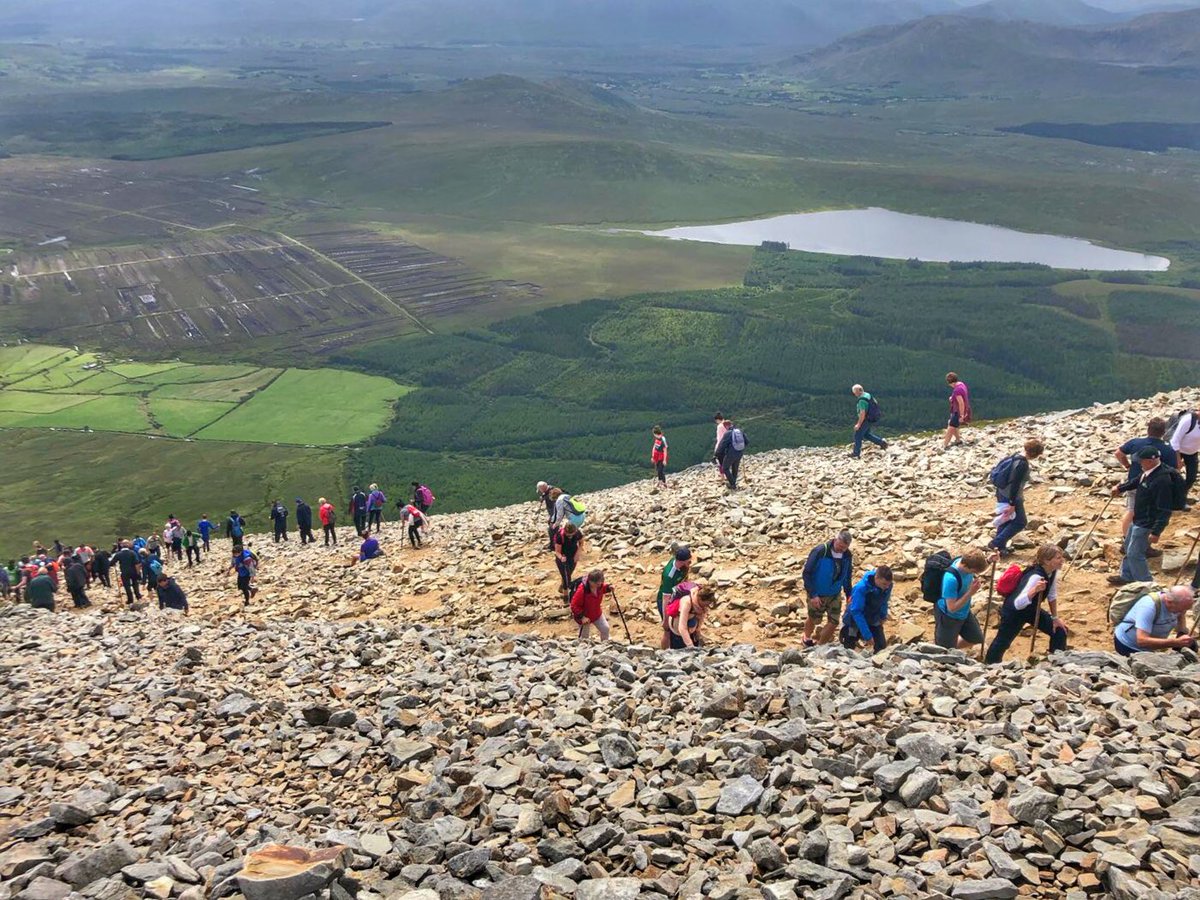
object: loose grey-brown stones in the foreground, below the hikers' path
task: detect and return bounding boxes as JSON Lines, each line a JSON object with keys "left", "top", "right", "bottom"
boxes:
{"left": 0, "top": 607, "right": 1200, "bottom": 900}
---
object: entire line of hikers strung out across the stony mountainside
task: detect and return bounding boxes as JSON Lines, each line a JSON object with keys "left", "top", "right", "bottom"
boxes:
{"left": 0, "top": 372, "right": 1200, "bottom": 662}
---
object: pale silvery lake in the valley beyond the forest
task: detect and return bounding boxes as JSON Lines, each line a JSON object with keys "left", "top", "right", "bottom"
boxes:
{"left": 642, "top": 208, "right": 1171, "bottom": 271}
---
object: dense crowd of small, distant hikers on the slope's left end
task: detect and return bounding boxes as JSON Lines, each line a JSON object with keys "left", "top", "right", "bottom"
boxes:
{"left": 0, "top": 481, "right": 437, "bottom": 616}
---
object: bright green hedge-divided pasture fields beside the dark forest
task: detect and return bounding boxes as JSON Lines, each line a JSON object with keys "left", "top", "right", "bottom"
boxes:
{"left": 0, "top": 344, "right": 408, "bottom": 446}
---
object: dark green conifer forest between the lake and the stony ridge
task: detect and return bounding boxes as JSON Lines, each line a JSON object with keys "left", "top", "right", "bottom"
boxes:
{"left": 335, "top": 251, "right": 1200, "bottom": 509}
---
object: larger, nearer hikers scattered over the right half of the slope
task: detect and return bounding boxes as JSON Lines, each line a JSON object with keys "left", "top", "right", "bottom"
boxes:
{"left": 547, "top": 372, "right": 1200, "bottom": 664}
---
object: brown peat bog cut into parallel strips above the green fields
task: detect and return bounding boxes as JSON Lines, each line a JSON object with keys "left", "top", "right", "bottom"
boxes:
{"left": 0, "top": 229, "right": 544, "bottom": 354}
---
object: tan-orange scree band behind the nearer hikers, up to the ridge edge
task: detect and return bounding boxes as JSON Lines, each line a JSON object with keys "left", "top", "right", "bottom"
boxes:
{"left": 162, "top": 389, "right": 1200, "bottom": 655}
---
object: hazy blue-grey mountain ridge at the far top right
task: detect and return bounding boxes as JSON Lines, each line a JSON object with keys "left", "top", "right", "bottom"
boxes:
{"left": 785, "top": 7, "right": 1200, "bottom": 90}
